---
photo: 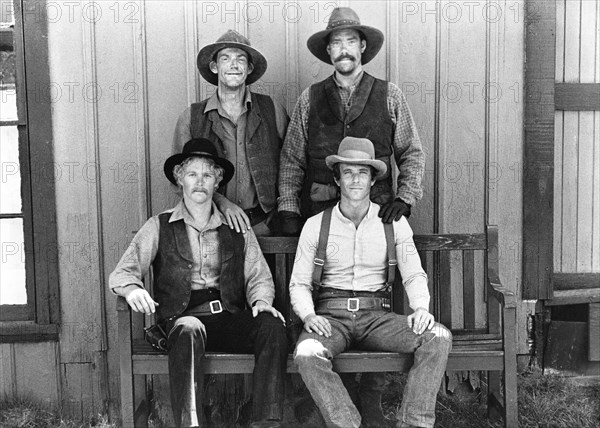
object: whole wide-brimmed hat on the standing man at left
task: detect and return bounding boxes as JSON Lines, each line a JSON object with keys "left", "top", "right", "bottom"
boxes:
{"left": 196, "top": 30, "right": 267, "bottom": 85}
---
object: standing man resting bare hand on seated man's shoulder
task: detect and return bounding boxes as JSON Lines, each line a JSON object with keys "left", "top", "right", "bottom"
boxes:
{"left": 173, "top": 30, "right": 289, "bottom": 236}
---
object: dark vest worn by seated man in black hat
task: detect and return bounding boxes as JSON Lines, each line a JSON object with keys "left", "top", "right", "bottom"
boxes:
{"left": 152, "top": 213, "right": 247, "bottom": 320}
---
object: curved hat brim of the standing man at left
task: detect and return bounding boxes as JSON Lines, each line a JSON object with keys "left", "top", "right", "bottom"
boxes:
{"left": 196, "top": 42, "right": 267, "bottom": 86}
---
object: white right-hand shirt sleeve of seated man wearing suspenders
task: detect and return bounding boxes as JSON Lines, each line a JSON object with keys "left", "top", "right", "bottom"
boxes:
{"left": 394, "top": 216, "right": 430, "bottom": 310}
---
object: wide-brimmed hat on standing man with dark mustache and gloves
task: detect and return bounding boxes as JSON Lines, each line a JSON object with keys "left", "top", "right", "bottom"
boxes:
{"left": 306, "top": 7, "right": 383, "bottom": 64}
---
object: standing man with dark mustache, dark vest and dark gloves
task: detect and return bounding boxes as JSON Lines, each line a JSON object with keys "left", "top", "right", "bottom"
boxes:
{"left": 278, "top": 7, "right": 425, "bottom": 426}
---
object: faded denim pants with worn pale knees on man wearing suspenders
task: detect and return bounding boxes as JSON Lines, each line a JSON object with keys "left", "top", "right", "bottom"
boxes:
{"left": 294, "top": 309, "right": 452, "bottom": 428}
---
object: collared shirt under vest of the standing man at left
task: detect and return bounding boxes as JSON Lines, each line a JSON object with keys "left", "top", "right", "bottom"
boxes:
{"left": 173, "top": 87, "right": 288, "bottom": 209}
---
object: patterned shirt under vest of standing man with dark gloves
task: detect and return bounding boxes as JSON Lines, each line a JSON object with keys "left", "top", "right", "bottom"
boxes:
{"left": 277, "top": 75, "right": 425, "bottom": 214}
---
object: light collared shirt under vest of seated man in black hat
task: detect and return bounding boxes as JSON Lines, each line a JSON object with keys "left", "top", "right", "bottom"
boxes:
{"left": 109, "top": 201, "right": 275, "bottom": 305}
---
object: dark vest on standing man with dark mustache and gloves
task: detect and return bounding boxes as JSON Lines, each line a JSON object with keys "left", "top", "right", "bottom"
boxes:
{"left": 305, "top": 73, "right": 394, "bottom": 207}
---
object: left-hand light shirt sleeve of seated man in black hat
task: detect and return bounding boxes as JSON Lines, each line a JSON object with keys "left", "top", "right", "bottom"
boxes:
{"left": 108, "top": 216, "right": 160, "bottom": 294}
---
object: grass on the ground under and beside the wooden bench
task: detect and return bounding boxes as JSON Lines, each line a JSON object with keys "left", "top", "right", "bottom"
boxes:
{"left": 0, "top": 371, "right": 600, "bottom": 428}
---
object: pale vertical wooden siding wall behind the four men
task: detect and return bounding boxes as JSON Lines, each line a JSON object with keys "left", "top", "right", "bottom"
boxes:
{"left": 0, "top": 0, "right": 528, "bottom": 415}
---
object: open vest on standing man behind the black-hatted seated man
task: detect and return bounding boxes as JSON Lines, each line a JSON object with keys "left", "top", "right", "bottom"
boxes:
{"left": 191, "top": 92, "right": 282, "bottom": 212}
